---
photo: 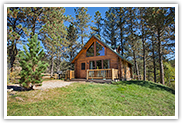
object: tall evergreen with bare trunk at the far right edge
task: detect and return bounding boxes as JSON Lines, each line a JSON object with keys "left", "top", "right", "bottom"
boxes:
{"left": 148, "top": 7, "right": 175, "bottom": 84}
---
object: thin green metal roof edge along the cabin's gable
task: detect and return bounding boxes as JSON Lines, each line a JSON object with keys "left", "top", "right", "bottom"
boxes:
{"left": 72, "top": 35, "right": 133, "bottom": 65}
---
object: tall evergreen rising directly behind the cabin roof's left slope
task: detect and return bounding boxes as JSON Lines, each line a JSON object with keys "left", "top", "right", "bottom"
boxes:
{"left": 74, "top": 7, "right": 91, "bottom": 46}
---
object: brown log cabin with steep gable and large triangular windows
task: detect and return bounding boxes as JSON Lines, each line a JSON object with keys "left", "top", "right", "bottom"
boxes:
{"left": 71, "top": 35, "right": 133, "bottom": 80}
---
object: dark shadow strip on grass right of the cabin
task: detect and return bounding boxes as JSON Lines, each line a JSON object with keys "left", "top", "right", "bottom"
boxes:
{"left": 113, "top": 80, "right": 175, "bottom": 94}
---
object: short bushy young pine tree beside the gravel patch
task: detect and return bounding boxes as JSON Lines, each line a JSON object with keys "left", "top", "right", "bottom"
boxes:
{"left": 19, "top": 35, "right": 47, "bottom": 88}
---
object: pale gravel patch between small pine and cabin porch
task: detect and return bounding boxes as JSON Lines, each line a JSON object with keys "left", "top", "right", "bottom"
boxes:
{"left": 34, "top": 80, "right": 74, "bottom": 89}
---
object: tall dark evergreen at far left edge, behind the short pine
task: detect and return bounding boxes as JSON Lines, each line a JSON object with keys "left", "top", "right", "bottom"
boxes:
{"left": 7, "top": 7, "right": 27, "bottom": 72}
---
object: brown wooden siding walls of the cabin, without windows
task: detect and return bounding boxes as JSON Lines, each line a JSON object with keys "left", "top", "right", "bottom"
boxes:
{"left": 72, "top": 37, "right": 132, "bottom": 80}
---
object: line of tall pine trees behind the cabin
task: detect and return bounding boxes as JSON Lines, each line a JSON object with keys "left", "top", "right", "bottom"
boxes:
{"left": 7, "top": 7, "right": 175, "bottom": 88}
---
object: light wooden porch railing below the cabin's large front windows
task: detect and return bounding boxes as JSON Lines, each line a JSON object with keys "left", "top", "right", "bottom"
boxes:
{"left": 86, "top": 68, "right": 118, "bottom": 80}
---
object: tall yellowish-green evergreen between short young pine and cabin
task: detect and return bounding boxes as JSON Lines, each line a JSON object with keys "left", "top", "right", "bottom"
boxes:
{"left": 40, "top": 7, "right": 67, "bottom": 77}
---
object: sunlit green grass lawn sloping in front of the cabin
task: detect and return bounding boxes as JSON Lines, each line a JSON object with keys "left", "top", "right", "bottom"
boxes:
{"left": 7, "top": 81, "right": 175, "bottom": 116}
